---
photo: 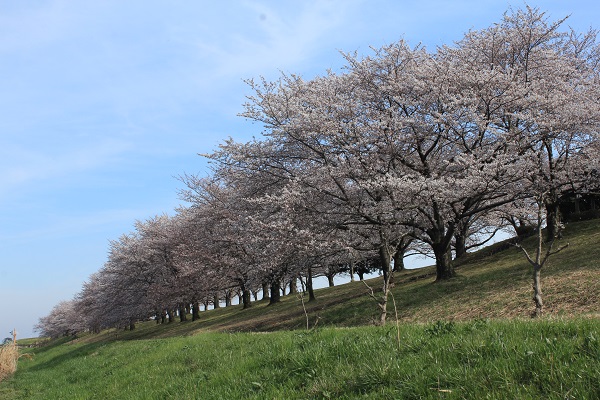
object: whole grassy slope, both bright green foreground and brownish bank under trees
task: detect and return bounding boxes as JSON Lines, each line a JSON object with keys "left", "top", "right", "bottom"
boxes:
{"left": 0, "top": 220, "right": 600, "bottom": 399}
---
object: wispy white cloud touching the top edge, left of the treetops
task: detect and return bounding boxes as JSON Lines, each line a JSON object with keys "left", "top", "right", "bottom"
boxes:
{"left": 179, "top": 1, "right": 357, "bottom": 80}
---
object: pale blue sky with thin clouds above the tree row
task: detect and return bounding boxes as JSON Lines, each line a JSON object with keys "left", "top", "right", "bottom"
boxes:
{"left": 0, "top": 0, "right": 600, "bottom": 339}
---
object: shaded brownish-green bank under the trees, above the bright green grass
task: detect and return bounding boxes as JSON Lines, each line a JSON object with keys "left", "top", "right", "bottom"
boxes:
{"left": 67, "top": 220, "right": 600, "bottom": 340}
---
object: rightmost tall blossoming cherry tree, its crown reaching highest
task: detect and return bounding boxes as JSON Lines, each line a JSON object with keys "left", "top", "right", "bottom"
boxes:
{"left": 459, "top": 7, "right": 600, "bottom": 241}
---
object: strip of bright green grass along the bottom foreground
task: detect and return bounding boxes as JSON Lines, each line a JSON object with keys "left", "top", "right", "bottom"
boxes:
{"left": 0, "top": 318, "right": 600, "bottom": 399}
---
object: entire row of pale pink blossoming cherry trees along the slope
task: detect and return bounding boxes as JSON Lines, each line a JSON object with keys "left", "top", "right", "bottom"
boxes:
{"left": 39, "top": 7, "right": 600, "bottom": 334}
